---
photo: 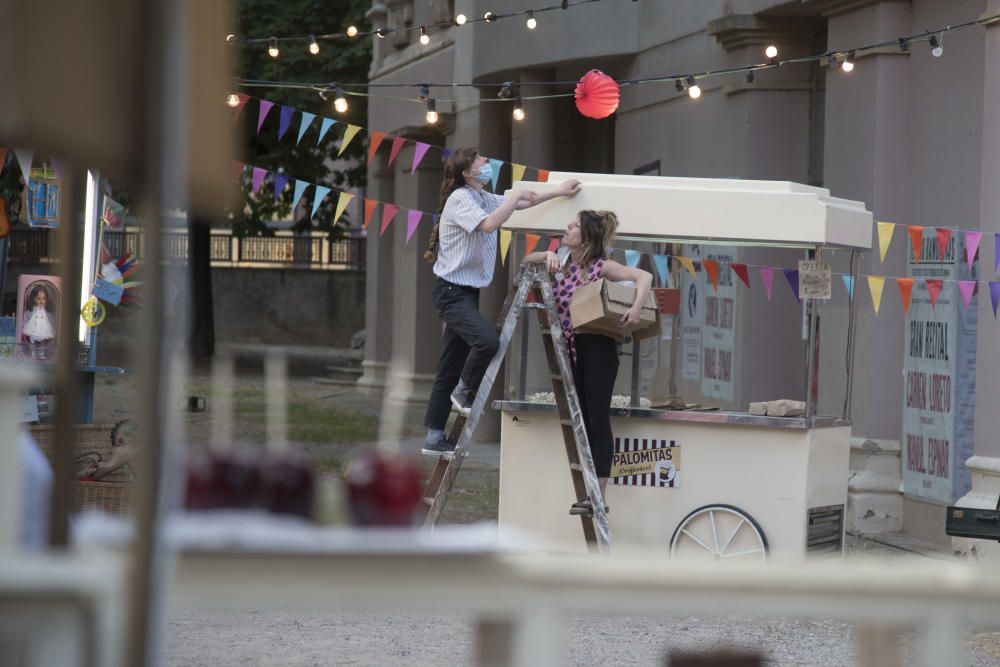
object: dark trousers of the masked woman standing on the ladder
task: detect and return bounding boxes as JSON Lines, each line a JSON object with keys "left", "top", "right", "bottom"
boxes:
{"left": 424, "top": 278, "right": 499, "bottom": 429}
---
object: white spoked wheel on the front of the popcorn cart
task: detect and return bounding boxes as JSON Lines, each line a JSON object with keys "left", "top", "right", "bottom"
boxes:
{"left": 670, "top": 504, "right": 767, "bottom": 560}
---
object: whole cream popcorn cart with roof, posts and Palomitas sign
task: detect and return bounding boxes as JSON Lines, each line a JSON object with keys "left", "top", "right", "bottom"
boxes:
{"left": 494, "top": 173, "right": 872, "bottom": 559}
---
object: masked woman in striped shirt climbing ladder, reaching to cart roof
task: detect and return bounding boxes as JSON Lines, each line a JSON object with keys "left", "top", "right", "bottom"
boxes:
{"left": 421, "top": 148, "right": 580, "bottom": 456}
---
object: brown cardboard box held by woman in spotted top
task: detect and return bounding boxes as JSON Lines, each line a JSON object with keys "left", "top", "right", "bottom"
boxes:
{"left": 569, "top": 278, "right": 660, "bottom": 341}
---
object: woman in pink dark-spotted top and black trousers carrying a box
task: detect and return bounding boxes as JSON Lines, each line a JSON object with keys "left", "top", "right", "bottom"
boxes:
{"left": 524, "top": 211, "right": 653, "bottom": 511}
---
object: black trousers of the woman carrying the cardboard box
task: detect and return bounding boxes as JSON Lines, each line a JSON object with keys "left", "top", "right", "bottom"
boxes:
{"left": 573, "top": 334, "right": 618, "bottom": 477}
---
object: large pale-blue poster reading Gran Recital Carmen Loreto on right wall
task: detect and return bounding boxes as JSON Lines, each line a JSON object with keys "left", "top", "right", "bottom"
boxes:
{"left": 902, "top": 228, "right": 978, "bottom": 504}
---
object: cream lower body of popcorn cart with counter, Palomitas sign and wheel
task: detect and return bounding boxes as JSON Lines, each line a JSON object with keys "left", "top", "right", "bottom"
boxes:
{"left": 494, "top": 401, "right": 851, "bottom": 559}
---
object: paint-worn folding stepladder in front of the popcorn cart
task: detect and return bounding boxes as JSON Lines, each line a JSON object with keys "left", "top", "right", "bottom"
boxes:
{"left": 414, "top": 264, "right": 611, "bottom": 551}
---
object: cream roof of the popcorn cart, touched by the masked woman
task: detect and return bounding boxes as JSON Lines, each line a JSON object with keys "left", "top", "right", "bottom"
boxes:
{"left": 504, "top": 172, "right": 872, "bottom": 249}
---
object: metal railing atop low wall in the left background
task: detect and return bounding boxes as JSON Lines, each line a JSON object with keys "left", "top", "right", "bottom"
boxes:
{"left": 8, "top": 229, "right": 365, "bottom": 271}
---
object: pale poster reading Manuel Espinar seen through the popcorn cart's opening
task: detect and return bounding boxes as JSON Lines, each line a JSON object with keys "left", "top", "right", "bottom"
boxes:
{"left": 701, "top": 246, "right": 736, "bottom": 401}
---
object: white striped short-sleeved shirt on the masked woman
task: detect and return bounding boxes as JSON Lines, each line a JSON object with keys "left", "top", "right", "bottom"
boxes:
{"left": 434, "top": 185, "right": 504, "bottom": 287}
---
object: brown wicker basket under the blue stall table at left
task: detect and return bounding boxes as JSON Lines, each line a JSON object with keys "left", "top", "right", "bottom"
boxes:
{"left": 29, "top": 424, "right": 132, "bottom": 515}
